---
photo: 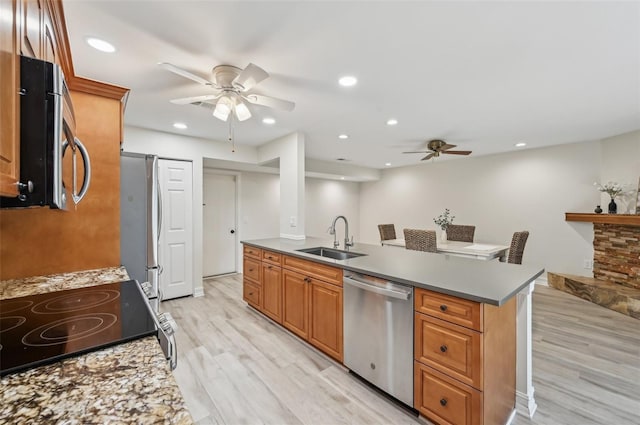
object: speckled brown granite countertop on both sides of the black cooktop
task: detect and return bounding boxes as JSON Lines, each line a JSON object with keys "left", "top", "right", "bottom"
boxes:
{"left": 0, "top": 267, "right": 193, "bottom": 424}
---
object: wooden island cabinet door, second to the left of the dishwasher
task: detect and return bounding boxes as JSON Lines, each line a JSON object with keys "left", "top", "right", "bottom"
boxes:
{"left": 282, "top": 270, "right": 309, "bottom": 340}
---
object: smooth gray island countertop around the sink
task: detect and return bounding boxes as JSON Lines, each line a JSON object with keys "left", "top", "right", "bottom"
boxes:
{"left": 242, "top": 237, "right": 544, "bottom": 305}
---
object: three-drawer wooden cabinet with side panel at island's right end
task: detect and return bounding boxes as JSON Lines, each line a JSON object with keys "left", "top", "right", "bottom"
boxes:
{"left": 414, "top": 288, "right": 516, "bottom": 425}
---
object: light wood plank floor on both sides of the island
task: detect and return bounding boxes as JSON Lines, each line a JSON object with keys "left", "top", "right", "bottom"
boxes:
{"left": 162, "top": 275, "right": 640, "bottom": 425}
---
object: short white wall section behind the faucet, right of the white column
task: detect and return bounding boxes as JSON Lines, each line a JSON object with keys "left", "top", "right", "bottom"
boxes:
{"left": 305, "top": 177, "right": 360, "bottom": 242}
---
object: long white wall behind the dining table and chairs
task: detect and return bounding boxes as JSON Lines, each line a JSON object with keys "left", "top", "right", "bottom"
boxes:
{"left": 360, "top": 142, "right": 608, "bottom": 275}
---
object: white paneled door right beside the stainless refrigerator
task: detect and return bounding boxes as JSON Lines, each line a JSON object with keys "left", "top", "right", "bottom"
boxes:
{"left": 158, "top": 159, "right": 193, "bottom": 300}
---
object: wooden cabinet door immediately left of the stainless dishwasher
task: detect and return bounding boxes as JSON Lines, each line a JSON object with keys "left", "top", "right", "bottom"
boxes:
{"left": 309, "top": 279, "right": 343, "bottom": 362}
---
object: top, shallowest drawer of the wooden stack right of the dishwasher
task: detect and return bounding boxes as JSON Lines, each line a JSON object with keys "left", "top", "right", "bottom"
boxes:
{"left": 415, "top": 288, "right": 482, "bottom": 332}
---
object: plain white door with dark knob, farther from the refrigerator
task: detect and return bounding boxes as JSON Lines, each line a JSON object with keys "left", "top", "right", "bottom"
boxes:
{"left": 202, "top": 174, "right": 238, "bottom": 276}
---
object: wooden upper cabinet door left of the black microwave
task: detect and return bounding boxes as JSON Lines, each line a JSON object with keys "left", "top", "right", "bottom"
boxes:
{"left": 0, "top": 0, "right": 20, "bottom": 196}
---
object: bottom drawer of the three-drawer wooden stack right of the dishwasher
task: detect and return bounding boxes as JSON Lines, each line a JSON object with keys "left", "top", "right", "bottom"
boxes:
{"left": 413, "top": 362, "right": 483, "bottom": 425}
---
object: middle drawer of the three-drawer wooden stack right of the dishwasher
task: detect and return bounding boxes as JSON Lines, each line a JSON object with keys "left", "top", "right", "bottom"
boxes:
{"left": 414, "top": 313, "right": 482, "bottom": 390}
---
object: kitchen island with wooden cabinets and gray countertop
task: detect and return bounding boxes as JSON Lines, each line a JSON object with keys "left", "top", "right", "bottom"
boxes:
{"left": 243, "top": 238, "right": 543, "bottom": 425}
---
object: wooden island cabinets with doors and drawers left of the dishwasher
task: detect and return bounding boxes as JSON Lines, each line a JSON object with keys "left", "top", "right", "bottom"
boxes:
{"left": 243, "top": 245, "right": 343, "bottom": 362}
